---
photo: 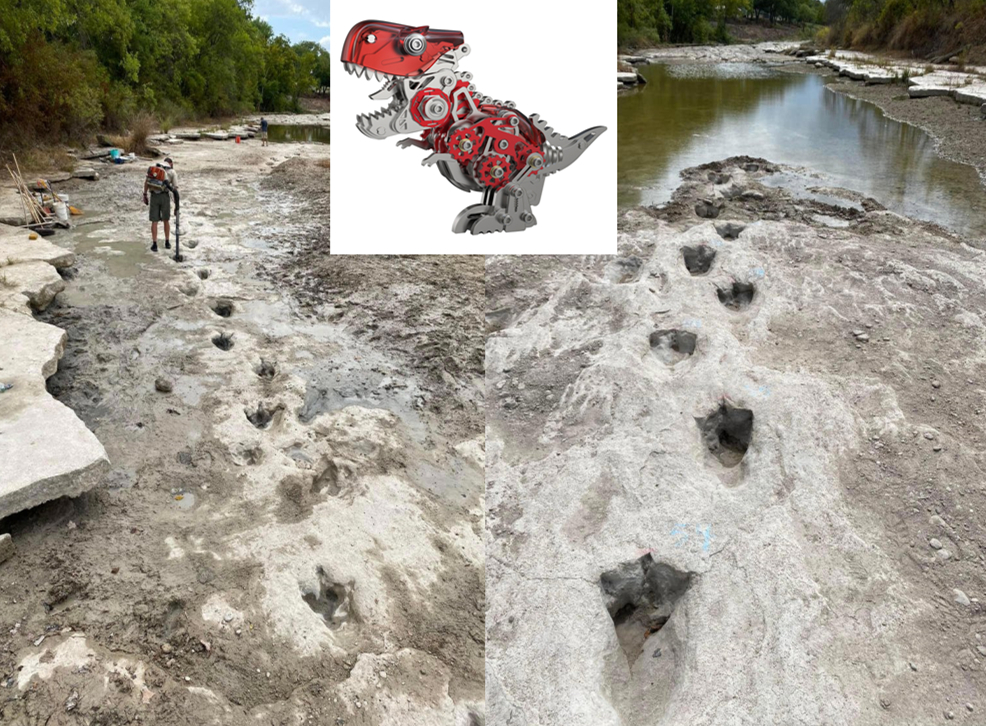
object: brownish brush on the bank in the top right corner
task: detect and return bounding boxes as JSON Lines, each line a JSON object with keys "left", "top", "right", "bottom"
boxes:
{"left": 820, "top": 0, "right": 986, "bottom": 64}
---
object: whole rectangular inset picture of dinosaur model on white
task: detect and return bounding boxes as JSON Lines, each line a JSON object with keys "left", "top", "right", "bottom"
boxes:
{"left": 331, "top": 0, "right": 616, "bottom": 254}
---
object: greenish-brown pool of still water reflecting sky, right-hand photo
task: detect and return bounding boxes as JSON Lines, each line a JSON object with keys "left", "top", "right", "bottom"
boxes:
{"left": 618, "top": 63, "right": 986, "bottom": 238}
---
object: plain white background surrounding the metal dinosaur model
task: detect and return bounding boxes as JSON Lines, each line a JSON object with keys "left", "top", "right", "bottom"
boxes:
{"left": 331, "top": 0, "right": 616, "bottom": 254}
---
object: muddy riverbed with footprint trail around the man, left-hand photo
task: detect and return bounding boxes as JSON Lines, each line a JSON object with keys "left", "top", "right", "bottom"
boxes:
{"left": 0, "top": 134, "right": 485, "bottom": 726}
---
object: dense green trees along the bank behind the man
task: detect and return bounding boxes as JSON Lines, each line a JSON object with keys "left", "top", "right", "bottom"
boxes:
{"left": 0, "top": 0, "right": 329, "bottom": 153}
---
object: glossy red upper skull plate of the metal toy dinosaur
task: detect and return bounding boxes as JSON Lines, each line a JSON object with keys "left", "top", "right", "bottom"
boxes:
{"left": 340, "top": 20, "right": 465, "bottom": 78}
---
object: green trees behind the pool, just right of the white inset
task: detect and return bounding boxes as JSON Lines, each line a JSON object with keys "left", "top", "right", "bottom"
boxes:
{"left": 617, "top": 0, "right": 825, "bottom": 49}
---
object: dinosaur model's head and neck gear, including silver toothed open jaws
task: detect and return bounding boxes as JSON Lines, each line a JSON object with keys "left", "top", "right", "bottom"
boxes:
{"left": 340, "top": 20, "right": 469, "bottom": 139}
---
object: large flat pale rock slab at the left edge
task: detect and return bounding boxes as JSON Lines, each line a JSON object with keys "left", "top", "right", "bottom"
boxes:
{"left": 0, "top": 308, "right": 108, "bottom": 519}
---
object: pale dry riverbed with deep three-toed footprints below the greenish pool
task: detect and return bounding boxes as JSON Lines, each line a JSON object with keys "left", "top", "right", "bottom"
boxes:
{"left": 486, "top": 158, "right": 986, "bottom": 726}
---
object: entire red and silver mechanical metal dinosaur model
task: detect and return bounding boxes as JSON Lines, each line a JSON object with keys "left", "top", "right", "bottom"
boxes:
{"left": 341, "top": 20, "right": 606, "bottom": 234}
